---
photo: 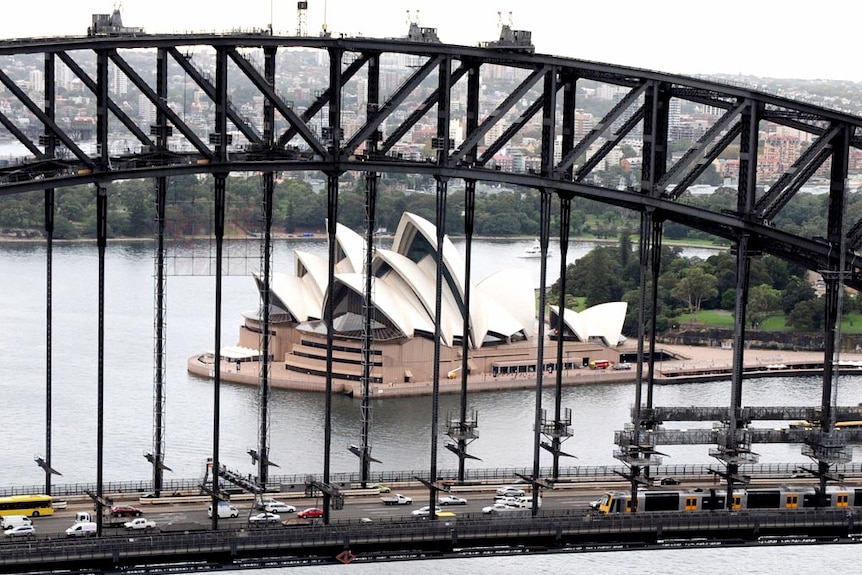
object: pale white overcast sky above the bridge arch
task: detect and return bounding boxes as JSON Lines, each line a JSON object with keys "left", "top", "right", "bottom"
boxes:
{"left": 0, "top": 0, "right": 862, "bottom": 81}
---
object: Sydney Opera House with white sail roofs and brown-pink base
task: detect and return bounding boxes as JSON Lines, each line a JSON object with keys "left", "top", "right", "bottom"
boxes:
{"left": 189, "top": 213, "right": 626, "bottom": 391}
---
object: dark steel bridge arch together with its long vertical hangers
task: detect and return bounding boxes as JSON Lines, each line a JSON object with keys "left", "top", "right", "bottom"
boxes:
{"left": 5, "top": 32, "right": 862, "bottom": 523}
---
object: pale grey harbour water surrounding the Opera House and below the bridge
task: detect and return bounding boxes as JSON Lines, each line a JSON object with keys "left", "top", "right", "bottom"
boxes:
{"left": 0, "top": 240, "right": 862, "bottom": 574}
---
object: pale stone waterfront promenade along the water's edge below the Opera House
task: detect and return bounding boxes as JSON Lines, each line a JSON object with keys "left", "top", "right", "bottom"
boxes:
{"left": 188, "top": 345, "right": 862, "bottom": 398}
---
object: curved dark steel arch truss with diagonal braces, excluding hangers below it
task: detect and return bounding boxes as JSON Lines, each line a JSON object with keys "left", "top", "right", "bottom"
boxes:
{"left": 0, "top": 34, "right": 862, "bottom": 288}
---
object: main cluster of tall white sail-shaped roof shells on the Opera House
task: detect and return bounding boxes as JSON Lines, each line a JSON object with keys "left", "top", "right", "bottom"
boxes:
{"left": 258, "top": 213, "right": 548, "bottom": 347}
